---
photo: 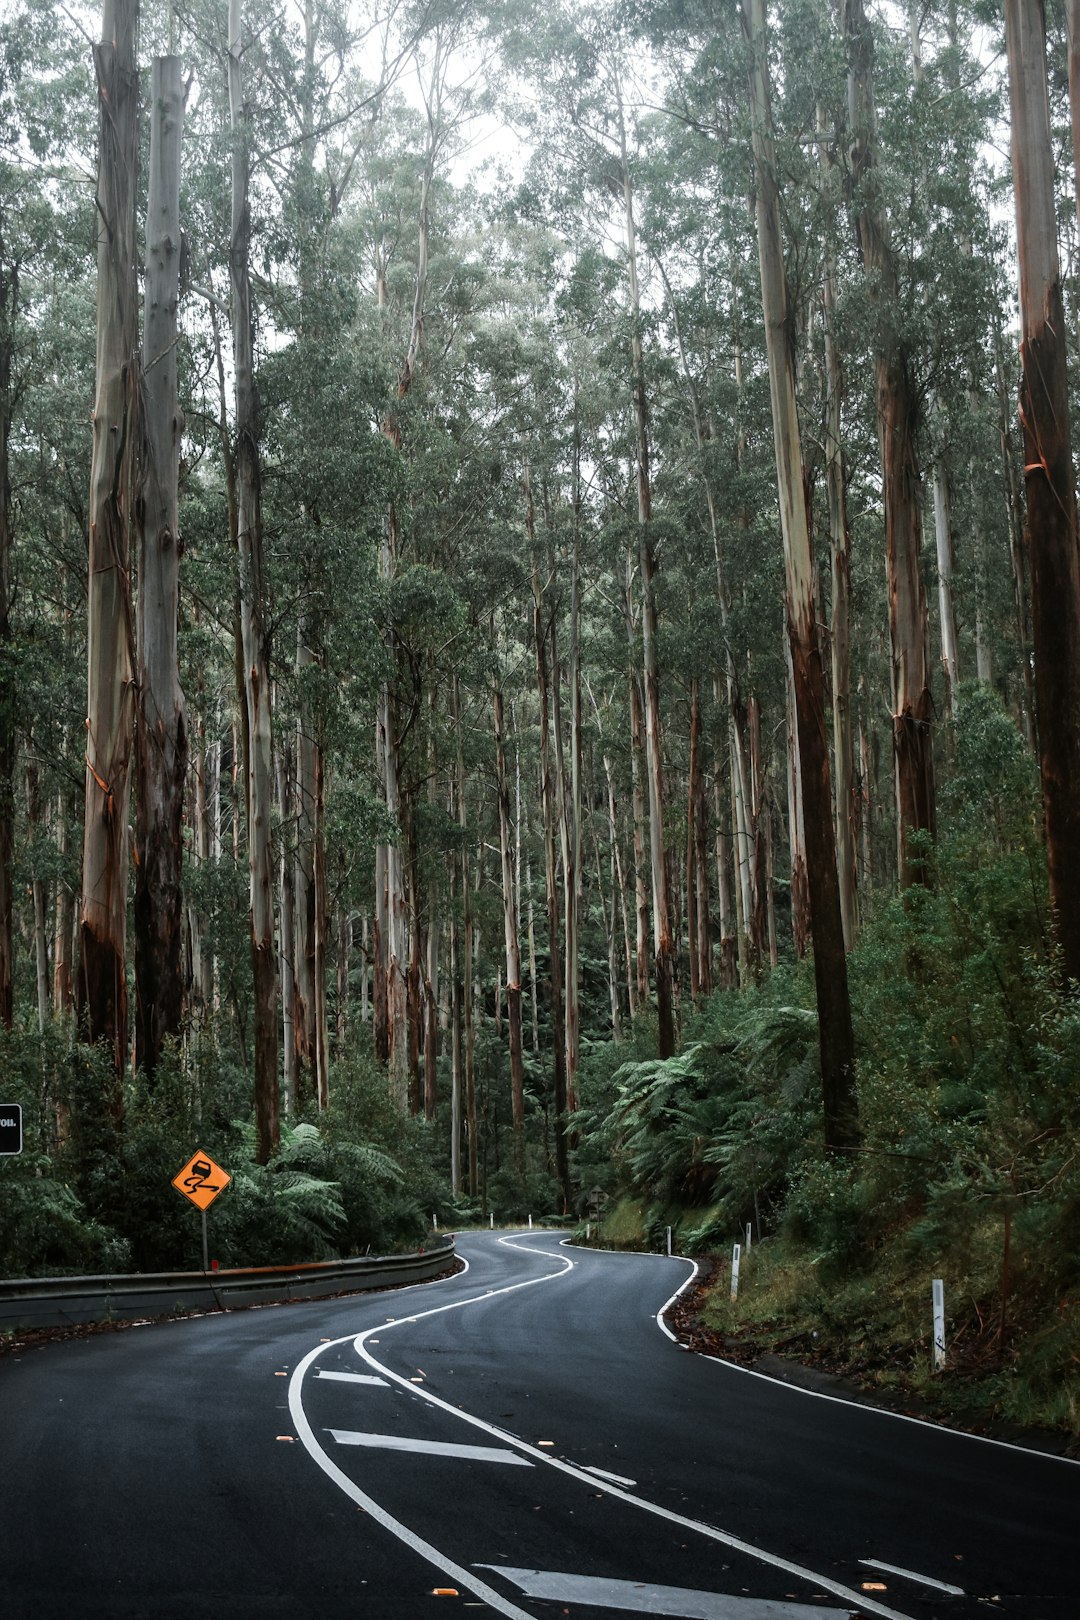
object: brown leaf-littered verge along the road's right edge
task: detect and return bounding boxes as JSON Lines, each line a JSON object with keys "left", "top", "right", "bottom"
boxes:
{"left": 665, "top": 1259, "right": 1080, "bottom": 1460}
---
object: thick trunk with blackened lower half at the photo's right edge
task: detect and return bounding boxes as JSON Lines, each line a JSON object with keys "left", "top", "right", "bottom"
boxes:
{"left": 1006, "top": 0, "right": 1080, "bottom": 990}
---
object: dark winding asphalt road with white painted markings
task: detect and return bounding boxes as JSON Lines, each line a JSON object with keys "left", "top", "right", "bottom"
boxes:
{"left": 0, "top": 1233, "right": 1080, "bottom": 1620}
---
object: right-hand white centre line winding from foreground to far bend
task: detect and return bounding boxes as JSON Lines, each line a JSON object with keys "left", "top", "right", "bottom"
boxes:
{"left": 341, "top": 1238, "right": 910, "bottom": 1620}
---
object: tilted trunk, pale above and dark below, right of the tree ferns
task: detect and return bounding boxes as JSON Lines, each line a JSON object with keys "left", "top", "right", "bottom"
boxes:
{"left": 743, "top": 0, "right": 858, "bottom": 1149}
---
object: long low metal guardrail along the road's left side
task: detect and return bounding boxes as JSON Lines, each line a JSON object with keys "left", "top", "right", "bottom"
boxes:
{"left": 0, "top": 1236, "right": 455, "bottom": 1332}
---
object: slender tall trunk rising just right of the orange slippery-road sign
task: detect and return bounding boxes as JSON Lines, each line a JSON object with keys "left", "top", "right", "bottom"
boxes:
{"left": 228, "top": 0, "right": 280, "bottom": 1163}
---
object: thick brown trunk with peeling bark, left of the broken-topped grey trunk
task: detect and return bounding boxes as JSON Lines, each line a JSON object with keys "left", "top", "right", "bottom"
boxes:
{"left": 78, "top": 0, "right": 139, "bottom": 1119}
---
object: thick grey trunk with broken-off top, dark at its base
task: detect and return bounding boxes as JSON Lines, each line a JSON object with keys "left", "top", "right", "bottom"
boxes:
{"left": 134, "top": 57, "right": 188, "bottom": 1076}
